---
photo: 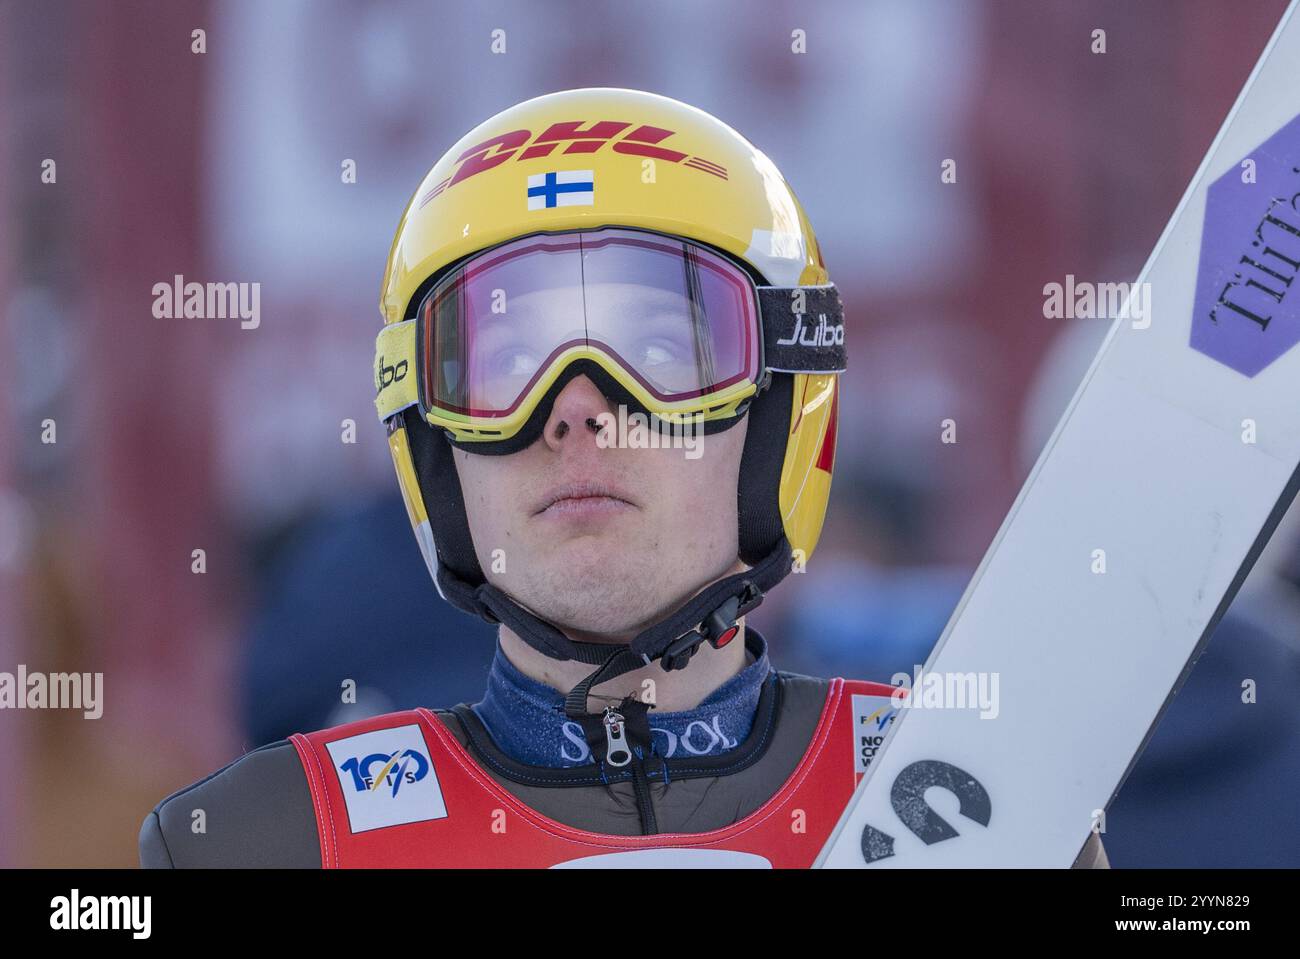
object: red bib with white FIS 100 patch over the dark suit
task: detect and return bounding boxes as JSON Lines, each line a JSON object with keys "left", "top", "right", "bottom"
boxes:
{"left": 291, "top": 680, "right": 894, "bottom": 868}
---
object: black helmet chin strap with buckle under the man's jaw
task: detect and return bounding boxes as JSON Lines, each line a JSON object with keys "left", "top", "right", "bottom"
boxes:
{"left": 443, "top": 537, "right": 790, "bottom": 719}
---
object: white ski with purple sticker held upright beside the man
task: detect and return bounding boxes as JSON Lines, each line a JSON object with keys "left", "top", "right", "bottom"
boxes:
{"left": 816, "top": 0, "right": 1300, "bottom": 868}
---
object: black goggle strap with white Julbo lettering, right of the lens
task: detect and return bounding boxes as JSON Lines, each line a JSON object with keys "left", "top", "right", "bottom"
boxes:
{"left": 757, "top": 283, "right": 849, "bottom": 373}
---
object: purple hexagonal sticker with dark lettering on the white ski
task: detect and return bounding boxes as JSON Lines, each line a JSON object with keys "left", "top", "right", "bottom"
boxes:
{"left": 1191, "top": 117, "right": 1300, "bottom": 377}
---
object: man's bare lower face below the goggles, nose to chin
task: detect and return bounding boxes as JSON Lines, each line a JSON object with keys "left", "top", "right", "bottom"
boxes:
{"left": 452, "top": 376, "right": 749, "bottom": 642}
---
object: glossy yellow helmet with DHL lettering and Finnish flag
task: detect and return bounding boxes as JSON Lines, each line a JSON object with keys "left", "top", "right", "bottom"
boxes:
{"left": 374, "top": 88, "right": 844, "bottom": 665}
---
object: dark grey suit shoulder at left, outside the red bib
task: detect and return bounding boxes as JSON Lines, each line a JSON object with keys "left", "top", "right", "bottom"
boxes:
{"left": 140, "top": 739, "right": 321, "bottom": 869}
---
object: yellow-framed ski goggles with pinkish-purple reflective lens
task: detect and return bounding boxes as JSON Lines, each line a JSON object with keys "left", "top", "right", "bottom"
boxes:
{"left": 374, "top": 227, "right": 842, "bottom": 442}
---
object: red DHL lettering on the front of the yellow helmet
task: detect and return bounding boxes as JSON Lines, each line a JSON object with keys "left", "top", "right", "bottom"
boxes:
{"left": 420, "top": 120, "right": 727, "bottom": 208}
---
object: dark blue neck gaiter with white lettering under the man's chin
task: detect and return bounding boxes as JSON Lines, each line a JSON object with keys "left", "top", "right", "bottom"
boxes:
{"left": 472, "top": 629, "right": 771, "bottom": 769}
